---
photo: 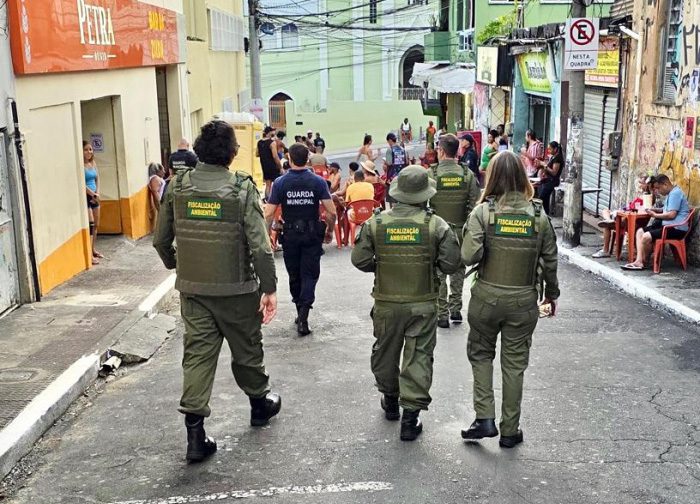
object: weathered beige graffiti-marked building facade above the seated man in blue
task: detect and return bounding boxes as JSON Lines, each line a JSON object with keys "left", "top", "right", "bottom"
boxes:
{"left": 614, "top": 0, "right": 700, "bottom": 264}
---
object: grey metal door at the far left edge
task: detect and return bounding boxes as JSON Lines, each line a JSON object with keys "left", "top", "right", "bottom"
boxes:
{"left": 0, "top": 134, "right": 19, "bottom": 314}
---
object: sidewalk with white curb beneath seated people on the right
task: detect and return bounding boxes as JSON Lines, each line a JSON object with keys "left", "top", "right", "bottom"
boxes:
{"left": 553, "top": 219, "right": 700, "bottom": 324}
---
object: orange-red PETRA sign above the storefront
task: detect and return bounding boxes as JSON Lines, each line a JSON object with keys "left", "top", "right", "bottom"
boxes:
{"left": 9, "top": 0, "right": 180, "bottom": 75}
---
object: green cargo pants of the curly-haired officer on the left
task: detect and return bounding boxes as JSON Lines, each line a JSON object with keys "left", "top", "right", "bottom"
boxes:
{"left": 178, "top": 292, "right": 270, "bottom": 417}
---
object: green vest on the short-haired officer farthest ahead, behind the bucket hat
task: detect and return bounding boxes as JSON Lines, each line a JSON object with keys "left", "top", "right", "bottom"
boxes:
{"left": 430, "top": 165, "right": 474, "bottom": 228}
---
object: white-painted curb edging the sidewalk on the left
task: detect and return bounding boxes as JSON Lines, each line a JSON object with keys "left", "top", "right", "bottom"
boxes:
{"left": 0, "top": 273, "right": 175, "bottom": 479}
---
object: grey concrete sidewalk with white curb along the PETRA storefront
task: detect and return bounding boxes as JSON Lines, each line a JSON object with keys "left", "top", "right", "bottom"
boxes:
{"left": 0, "top": 236, "right": 174, "bottom": 479}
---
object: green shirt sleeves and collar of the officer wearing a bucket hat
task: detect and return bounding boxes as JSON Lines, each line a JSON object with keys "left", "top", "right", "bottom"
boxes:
{"left": 351, "top": 203, "right": 461, "bottom": 275}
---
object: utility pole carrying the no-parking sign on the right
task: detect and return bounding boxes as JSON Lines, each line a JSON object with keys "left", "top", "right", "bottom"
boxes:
{"left": 563, "top": 0, "right": 590, "bottom": 247}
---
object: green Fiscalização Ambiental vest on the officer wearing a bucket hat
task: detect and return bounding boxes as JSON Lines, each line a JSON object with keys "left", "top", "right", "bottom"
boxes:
{"left": 372, "top": 208, "right": 438, "bottom": 303}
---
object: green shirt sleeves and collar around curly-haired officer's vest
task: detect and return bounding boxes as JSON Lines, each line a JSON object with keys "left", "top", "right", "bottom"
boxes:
{"left": 153, "top": 163, "right": 277, "bottom": 294}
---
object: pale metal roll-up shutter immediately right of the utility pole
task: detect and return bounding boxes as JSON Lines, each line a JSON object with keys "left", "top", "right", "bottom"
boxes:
{"left": 582, "top": 88, "right": 605, "bottom": 215}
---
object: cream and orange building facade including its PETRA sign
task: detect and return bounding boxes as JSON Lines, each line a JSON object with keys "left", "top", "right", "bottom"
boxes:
{"left": 9, "top": 0, "right": 190, "bottom": 293}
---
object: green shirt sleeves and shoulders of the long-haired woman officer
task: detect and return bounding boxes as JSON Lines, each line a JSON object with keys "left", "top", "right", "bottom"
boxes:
{"left": 462, "top": 193, "right": 559, "bottom": 300}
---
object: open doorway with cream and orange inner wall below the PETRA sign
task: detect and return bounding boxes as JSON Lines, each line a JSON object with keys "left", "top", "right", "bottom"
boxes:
{"left": 80, "top": 96, "right": 128, "bottom": 234}
